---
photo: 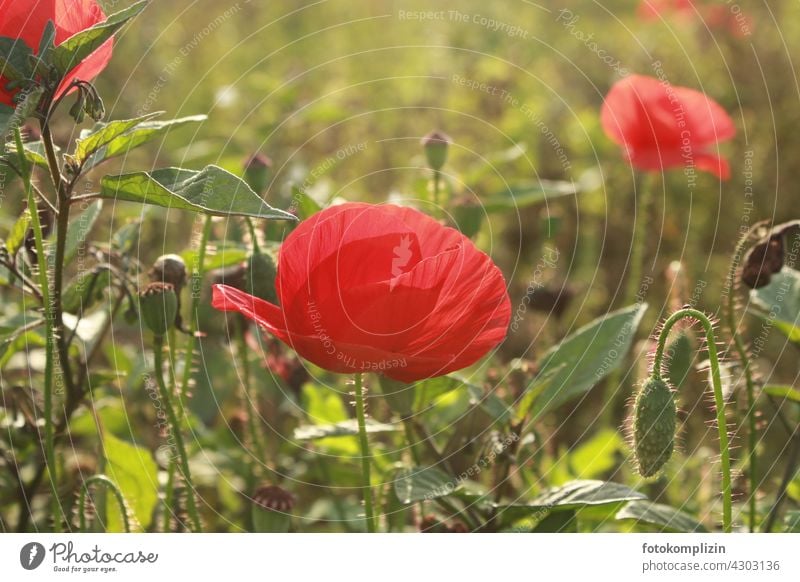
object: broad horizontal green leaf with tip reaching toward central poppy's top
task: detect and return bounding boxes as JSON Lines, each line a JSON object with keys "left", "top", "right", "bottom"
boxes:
{"left": 100, "top": 166, "right": 296, "bottom": 220}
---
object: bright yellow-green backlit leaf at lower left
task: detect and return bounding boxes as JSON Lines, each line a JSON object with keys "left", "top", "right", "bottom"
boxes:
{"left": 103, "top": 433, "right": 158, "bottom": 532}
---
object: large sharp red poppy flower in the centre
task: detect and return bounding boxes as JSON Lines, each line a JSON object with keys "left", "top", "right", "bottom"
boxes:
{"left": 213, "top": 203, "right": 511, "bottom": 382}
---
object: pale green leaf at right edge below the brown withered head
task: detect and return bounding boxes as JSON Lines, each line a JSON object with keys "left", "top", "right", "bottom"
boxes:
{"left": 750, "top": 267, "right": 800, "bottom": 343}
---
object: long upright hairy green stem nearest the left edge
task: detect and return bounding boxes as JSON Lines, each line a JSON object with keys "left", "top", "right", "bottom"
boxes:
{"left": 14, "top": 128, "right": 63, "bottom": 533}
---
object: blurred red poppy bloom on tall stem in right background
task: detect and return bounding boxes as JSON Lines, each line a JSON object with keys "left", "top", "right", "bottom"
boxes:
{"left": 601, "top": 75, "right": 736, "bottom": 180}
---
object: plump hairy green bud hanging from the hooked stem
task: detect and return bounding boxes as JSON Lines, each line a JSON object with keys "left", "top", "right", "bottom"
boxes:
{"left": 633, "top": 376, "right": 677, "bottom": 477}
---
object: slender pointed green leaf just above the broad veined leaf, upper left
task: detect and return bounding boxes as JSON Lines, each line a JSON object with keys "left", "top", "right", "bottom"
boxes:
{"left": 76, "top": 115, "right": 207, "bottom": 168}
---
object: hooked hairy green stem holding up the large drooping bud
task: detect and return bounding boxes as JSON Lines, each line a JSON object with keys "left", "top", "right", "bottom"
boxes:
{"left": 653, "top": 308, "right": 732, "bottom": 533}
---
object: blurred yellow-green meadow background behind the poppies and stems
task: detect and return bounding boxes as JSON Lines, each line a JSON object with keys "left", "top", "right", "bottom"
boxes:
{"left": 0, "top": 0, "right": 800, "bottom": 531}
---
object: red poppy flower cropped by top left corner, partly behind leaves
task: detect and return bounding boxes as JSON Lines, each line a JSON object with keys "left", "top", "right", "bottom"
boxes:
{"left": 0, "top": 0, "right": 114, "bottom": 105}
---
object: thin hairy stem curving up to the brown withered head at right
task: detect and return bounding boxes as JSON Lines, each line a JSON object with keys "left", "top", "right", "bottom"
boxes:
{"left": 725, "top": 227, "right": 758, "bottom": 532}
